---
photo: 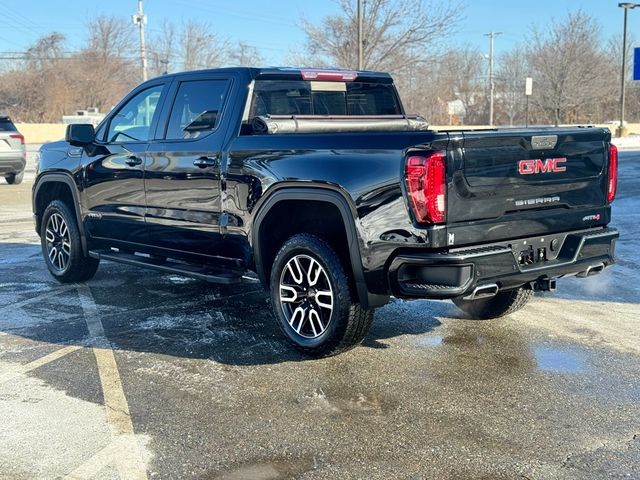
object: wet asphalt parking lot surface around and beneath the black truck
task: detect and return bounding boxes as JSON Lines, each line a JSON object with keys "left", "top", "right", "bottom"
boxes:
{"left": 0, "top": 151, "right": 640, "bottom": 479}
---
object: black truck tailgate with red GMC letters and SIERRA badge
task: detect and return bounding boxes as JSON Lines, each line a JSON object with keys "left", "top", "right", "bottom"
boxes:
{"left": 447, "top": 128, "right": 610, "bottom": 229}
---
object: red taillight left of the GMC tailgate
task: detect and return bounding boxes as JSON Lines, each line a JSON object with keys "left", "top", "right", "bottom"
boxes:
{"left": 406, "top": 151, "right": 447, "bottom": 223}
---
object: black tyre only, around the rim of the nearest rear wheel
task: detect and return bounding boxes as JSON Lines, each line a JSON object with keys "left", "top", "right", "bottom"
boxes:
{"left": 270, "top": 233, "right": 373, "bottom": 357}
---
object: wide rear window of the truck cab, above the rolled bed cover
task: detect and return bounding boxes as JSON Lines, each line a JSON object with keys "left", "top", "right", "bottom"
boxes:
{"left": 250, "top": 80, "right": 402, "bottom": 118}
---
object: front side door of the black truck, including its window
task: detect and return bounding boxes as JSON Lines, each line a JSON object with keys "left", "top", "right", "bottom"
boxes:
{"left": 83, "top": 82, "right": 165, "bottom": 243}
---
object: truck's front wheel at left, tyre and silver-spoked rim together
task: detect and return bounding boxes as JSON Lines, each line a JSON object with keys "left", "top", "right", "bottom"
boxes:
{"left": 40, "top": 200, "right": 99, "bottom": 283}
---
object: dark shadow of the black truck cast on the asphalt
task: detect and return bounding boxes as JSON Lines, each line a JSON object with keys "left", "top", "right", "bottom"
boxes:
{"left": 0, "top": 249, "right": 442, "bottom": 365}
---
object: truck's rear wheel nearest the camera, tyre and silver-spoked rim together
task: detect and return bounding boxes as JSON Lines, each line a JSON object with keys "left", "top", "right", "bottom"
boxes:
{"left": 270, "top": 234, "right": 373, "bottom": 356}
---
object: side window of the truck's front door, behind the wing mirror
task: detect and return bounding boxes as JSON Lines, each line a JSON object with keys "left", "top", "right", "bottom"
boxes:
{"left": 107, "top": 85, "right": 164, "bottom": 143}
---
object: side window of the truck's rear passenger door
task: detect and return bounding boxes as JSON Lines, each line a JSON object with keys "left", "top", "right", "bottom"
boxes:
{"left": 165, "top": 79, "right": 229, "bottom": 140}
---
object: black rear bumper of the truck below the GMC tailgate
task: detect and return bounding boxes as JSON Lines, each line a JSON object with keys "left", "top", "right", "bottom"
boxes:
{"left": 388, "top": 228, "right": 619, "bottom": 299}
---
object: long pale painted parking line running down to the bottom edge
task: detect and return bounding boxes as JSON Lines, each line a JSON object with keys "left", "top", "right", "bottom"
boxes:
{"left": 73, "top": 285, "right": 147, "bottom": 480}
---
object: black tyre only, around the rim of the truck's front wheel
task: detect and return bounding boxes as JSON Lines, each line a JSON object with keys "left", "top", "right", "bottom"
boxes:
{"left": 40, "top": 200, "right": 100, "bottom": 283}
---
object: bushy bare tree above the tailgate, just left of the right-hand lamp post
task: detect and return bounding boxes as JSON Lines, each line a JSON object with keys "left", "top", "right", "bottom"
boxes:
{"left": 527, "top": 11, "right": 615, "bottom": 125}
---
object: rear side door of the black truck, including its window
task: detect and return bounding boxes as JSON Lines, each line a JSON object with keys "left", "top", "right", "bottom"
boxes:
{"left": 145, "top": 76, "right": 231, "bottom": 257}
